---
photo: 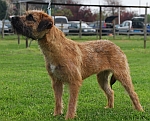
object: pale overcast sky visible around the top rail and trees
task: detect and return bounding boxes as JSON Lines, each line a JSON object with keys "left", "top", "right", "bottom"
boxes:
{"left": 82, "top": 0, "right": 150, "bottom": 14}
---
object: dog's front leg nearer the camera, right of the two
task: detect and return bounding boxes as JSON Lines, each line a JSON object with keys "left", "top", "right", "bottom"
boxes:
{"left": 66, "top": 83, "right": 80, "bottom": 120}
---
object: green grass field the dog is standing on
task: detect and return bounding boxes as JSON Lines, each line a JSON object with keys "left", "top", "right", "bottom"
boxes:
{"left": 0, "top": 36, "right": 150, "bottom": 121}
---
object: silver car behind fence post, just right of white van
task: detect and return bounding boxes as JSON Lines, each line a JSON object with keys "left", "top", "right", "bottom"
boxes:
{"left": 68, "top": 21, "right": 96, "bottom": 34}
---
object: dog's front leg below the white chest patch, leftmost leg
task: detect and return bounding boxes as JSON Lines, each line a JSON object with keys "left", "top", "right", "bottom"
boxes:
{"left": 53, "top": 81, "right": 63, "bottom": 116}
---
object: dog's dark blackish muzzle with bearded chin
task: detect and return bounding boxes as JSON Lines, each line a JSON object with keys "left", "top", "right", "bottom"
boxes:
{"left": 11, "top": 17, "right": 37, "bottom": 40}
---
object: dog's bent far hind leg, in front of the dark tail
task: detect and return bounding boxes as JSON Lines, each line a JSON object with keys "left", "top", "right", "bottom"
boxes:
{"left": 97, "top": 70, "right": 114, "bottom": 108}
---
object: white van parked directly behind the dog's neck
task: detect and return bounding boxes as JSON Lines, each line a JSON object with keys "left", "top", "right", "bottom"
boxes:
{"left": 52, "top": 16, "right": 69, "bottom": 34}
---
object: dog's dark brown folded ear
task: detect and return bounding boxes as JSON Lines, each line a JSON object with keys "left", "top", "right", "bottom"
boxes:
{"left": 37, "top": 19, "right": 53, "bottom": 32}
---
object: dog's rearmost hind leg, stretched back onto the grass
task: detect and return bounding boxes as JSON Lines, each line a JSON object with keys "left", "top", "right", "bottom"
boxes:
{"left": 115, "top": 71, "right": 143, "bottom": 111}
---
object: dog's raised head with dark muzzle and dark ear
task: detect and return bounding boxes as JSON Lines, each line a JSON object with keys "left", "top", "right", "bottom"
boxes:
{"left": 11, "top": 10, "right": 54, "bottom": 40}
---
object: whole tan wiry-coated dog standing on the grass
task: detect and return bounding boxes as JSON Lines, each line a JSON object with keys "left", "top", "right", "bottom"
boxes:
{"left": 12, "top": 10, "right": 143, "bottom": 119}
